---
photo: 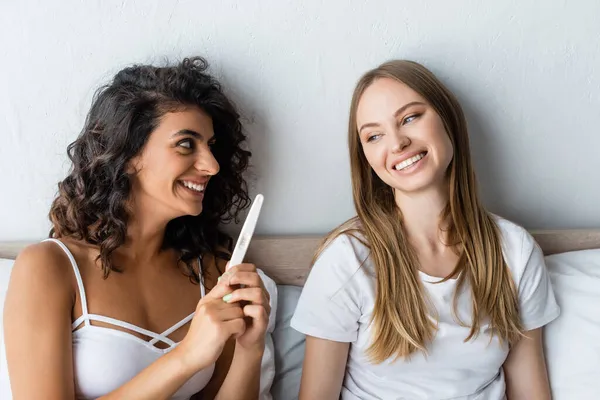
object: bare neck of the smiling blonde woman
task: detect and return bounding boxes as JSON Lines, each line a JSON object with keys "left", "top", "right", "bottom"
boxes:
{"left": 394, "top": 185, "right": 449, "bottom": 252}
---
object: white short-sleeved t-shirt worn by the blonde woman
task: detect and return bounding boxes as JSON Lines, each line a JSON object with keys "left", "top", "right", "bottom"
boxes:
{"left": 291, "top": 218, "right": 560, "bottom": 400}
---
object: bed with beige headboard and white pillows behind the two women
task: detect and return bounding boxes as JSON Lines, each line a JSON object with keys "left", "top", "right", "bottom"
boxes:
{"left": 0, "top": 229, "right": 600, "bottom": 400}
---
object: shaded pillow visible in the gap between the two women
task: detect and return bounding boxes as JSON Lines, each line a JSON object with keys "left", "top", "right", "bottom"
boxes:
{"left": 271, "top": 285, "right": 305, "bottom": 400}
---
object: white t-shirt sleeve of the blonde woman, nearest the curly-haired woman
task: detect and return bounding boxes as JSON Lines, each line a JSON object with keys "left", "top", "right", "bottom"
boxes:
{"left": 291, "top": 235, "right": 363, "bottom": 342}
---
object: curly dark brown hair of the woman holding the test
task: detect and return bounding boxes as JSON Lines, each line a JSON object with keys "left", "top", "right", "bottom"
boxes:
{"left": 50, "top": 57, "right": 251, "bottom": 282}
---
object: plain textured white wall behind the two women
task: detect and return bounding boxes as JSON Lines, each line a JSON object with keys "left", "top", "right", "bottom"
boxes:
{"left": 0, "top": 0, "right": 600, "bottom": 240}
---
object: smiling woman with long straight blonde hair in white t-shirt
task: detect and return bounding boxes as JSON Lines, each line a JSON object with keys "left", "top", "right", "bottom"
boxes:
{"left": 292, "top": 61, "right": 559, "bottom": 400}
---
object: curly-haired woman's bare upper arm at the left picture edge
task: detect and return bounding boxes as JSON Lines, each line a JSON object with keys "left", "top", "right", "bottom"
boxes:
{"left": 4, "top": 243, "right": 75, "bottom": 400}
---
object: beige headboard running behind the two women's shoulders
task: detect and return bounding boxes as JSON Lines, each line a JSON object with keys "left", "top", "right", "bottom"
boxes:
{"left": 0, "top": 229, "right": 600, "bottom": 286}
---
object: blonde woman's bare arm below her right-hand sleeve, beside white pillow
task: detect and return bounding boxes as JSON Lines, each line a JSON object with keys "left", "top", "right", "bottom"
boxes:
{"left": 503, "top": 328, "right": 552, "bottom": 400}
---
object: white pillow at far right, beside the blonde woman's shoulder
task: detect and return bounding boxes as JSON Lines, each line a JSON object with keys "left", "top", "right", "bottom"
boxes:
{"left": 544, "top": 249, "right": 600, "bottom": 400}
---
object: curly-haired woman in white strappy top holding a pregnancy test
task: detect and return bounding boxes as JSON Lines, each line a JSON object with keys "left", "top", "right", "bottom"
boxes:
{"left": 5, "top": 58, "right": 270, "bottom": 400}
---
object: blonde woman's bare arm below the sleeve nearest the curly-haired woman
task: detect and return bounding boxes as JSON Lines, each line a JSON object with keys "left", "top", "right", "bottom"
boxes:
{"left": 300, "top": 336, "right": 350, "bottom": 400}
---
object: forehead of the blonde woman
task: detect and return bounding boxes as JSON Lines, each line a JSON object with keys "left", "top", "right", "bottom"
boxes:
{"left": 356, "top": 78, "right": 426, "bottom": 125}
